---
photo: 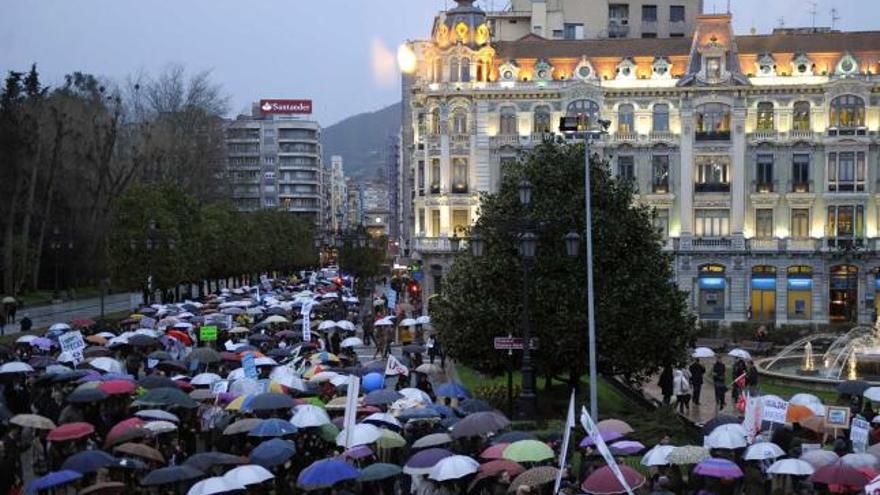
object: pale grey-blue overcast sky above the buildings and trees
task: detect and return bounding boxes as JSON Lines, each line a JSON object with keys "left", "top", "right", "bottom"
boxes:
{"left": 0, "top": 0, "right": 880, "bottom": 126}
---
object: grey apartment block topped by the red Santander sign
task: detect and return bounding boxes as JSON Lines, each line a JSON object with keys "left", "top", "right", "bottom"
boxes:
{"left": 226, "top": 103, "right": 323, "bottom": 226}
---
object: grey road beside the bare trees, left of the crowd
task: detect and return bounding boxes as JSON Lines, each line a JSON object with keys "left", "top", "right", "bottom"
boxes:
{"left": 6, "top": 292, "right": 142, "bottom": 335}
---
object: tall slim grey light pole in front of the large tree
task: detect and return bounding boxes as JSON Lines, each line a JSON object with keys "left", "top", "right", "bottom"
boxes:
{"left": 559, "top": 117, "right": 610, "bottom": 420}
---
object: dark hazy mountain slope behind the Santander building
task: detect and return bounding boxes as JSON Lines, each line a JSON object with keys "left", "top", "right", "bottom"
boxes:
{"left": 323, "top": 102, "right": 400, "bottom": 182}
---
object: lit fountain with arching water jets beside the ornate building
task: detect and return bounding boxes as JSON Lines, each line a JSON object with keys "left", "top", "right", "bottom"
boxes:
{"left": 756, "top": 318, "right": 880, "bottom": 388}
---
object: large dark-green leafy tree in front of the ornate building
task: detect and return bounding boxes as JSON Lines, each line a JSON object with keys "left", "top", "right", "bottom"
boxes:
{"left": 431, "top": 142, "right": 695, "bottom": 386}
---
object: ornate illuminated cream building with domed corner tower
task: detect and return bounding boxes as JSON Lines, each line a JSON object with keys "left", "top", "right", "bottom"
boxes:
{"left": 404, "top": 1, "right": 880, "bottom": 323}
